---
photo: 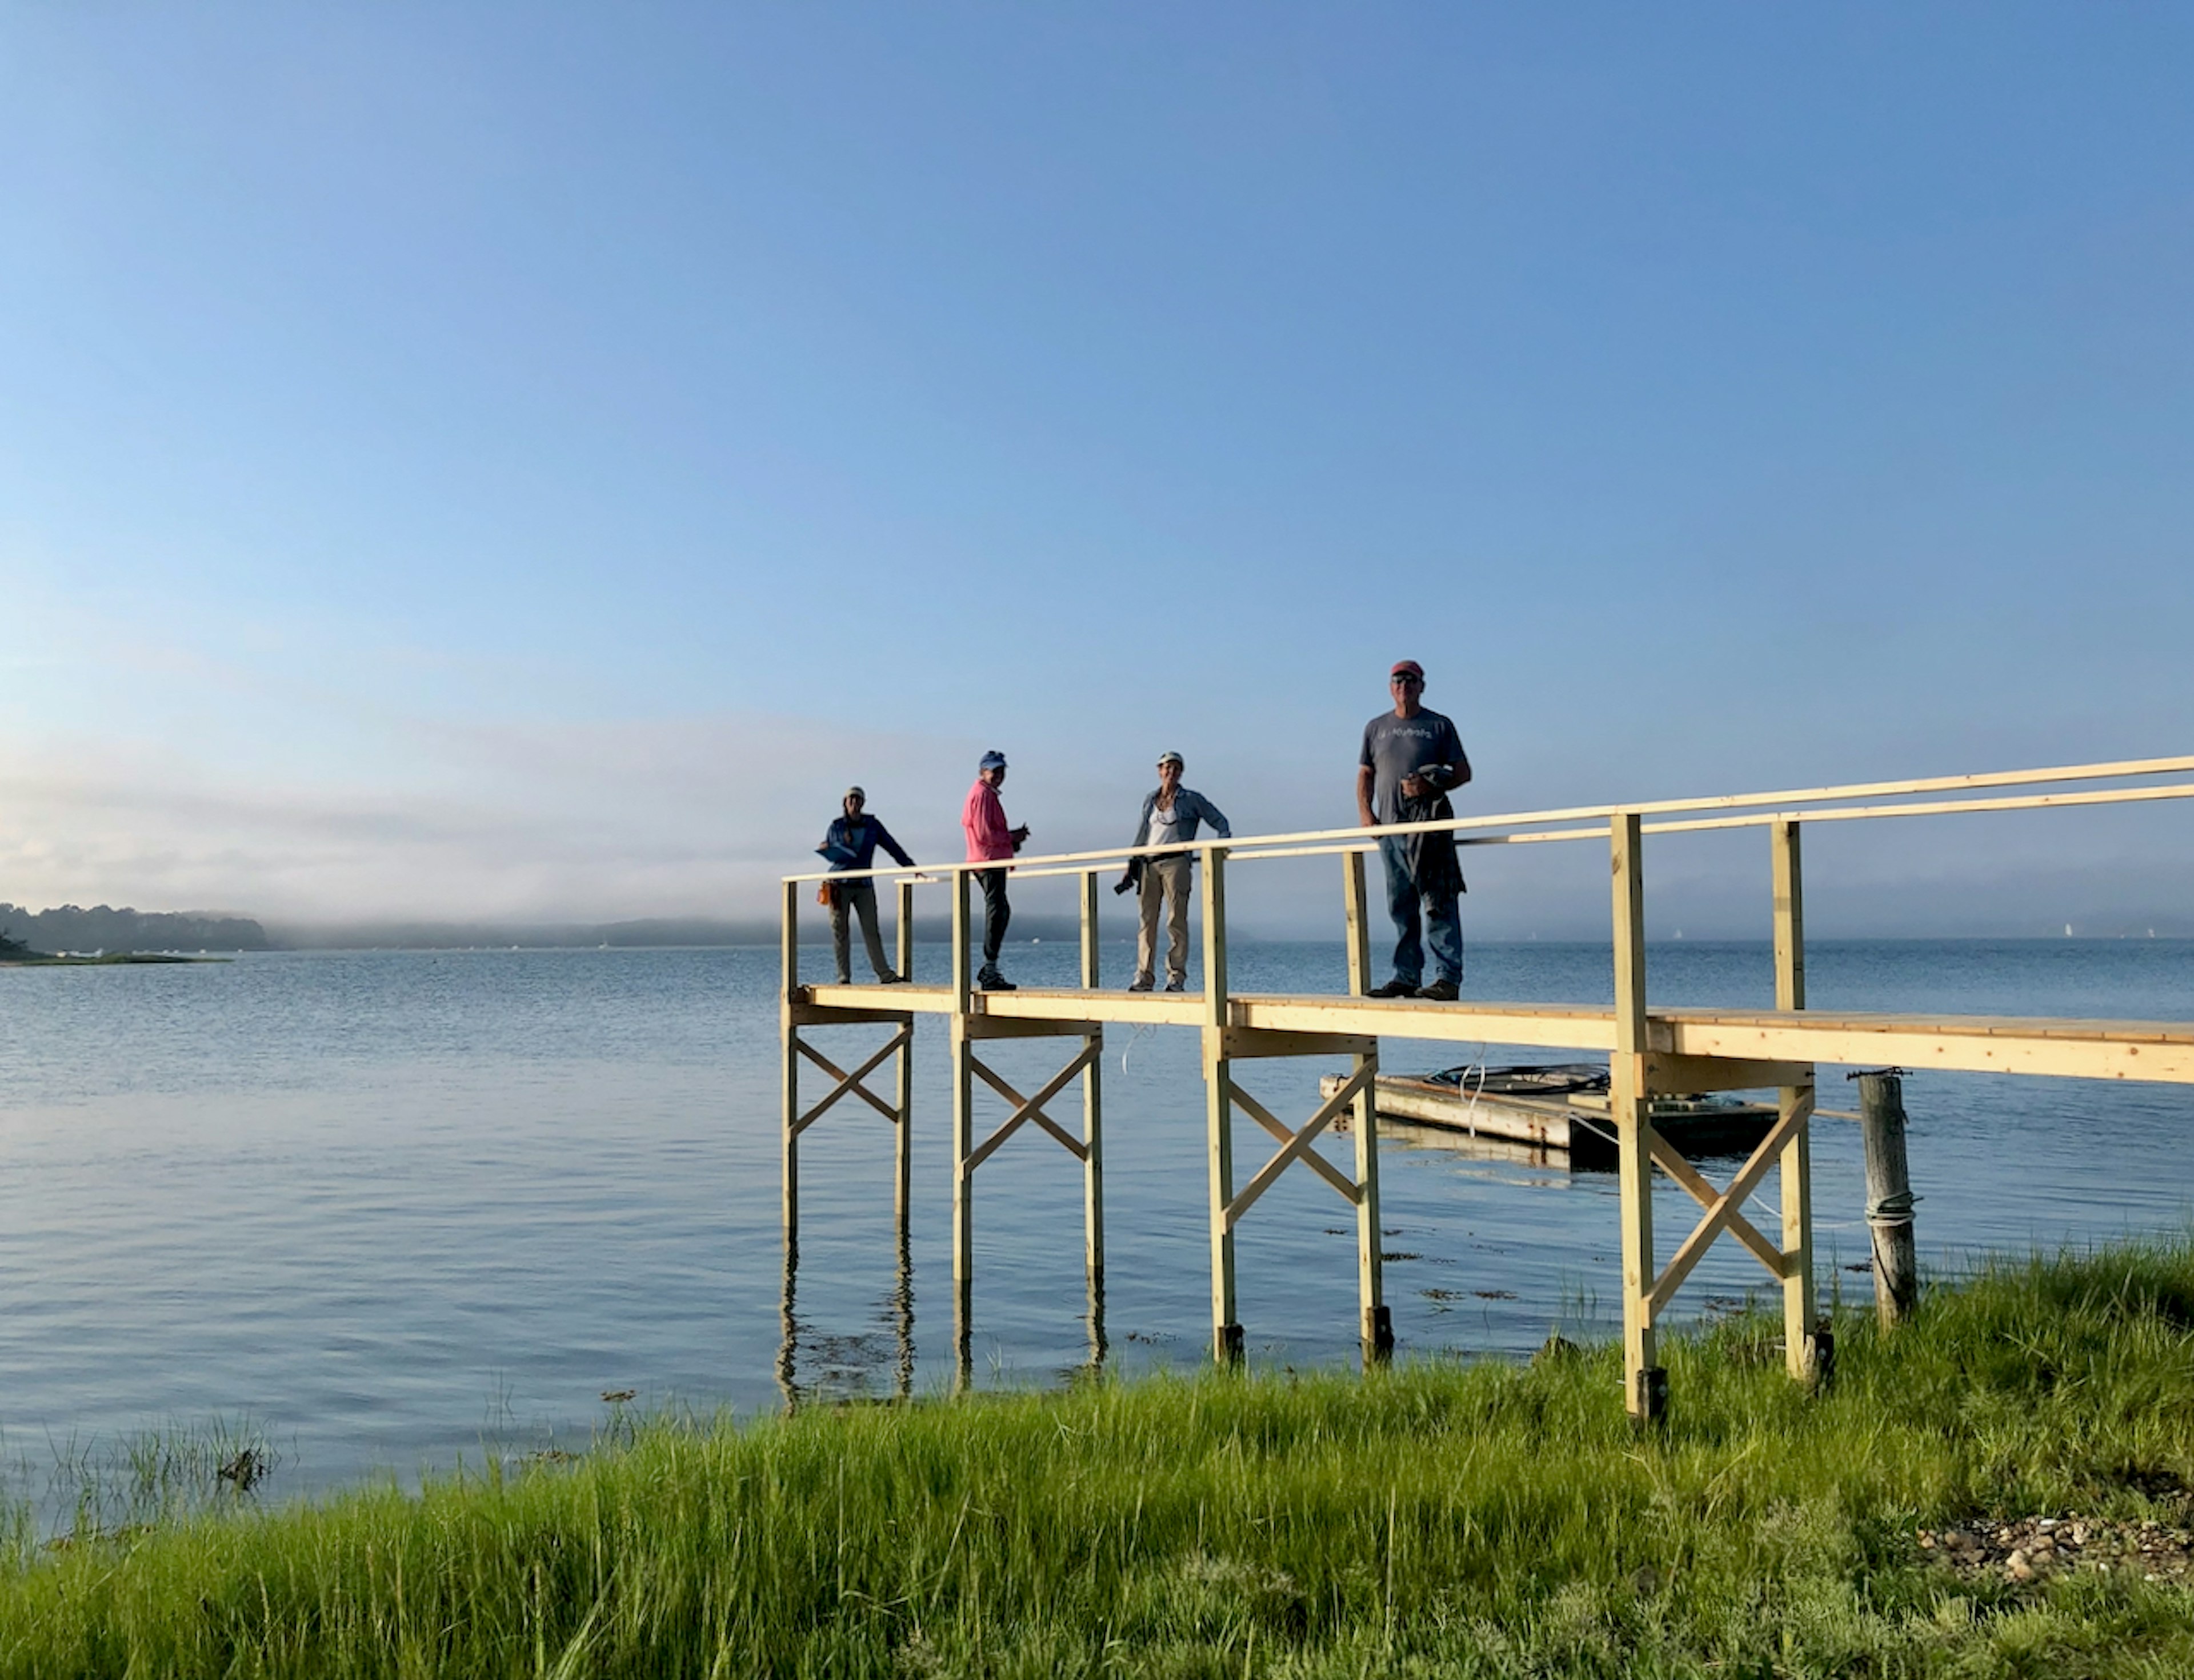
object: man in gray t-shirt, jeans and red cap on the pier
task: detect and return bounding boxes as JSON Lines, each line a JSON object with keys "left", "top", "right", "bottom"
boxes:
{"left": 1356, "top": 660, "right": 1470, "bottom": 1002}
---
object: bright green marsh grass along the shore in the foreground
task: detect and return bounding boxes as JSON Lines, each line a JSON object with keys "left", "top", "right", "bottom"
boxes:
{"left": 0, "top": 1239, "right": 2194, "bottom": 1680}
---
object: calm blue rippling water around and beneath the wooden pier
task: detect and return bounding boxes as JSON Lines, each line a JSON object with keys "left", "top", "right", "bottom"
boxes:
{"left": 0, "top": 941, "right": 2194, "bottom": 1491}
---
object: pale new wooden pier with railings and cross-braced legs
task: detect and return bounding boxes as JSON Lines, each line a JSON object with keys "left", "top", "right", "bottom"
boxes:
{"left": 781, "top": 757, "right": 2194, "bottom": 1419}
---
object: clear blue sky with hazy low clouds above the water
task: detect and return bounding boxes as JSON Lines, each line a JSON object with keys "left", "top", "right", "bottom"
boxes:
{"left": 0, "top": 5, "right": 2194, "bottom": 937}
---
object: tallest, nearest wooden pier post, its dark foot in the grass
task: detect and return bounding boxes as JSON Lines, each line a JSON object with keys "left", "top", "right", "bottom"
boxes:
{"left": 1608, "top": 811, "right": 1667, "bottom": 1423}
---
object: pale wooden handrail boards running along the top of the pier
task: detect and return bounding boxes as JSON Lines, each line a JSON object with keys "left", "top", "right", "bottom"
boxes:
{"left": 783, "top": 757, "right": 2194, "bottom": 882}
